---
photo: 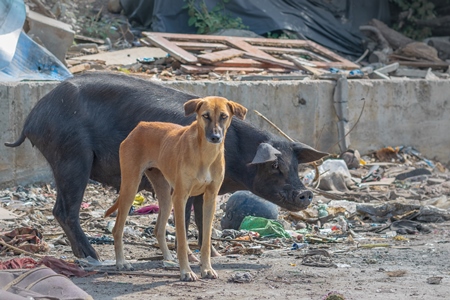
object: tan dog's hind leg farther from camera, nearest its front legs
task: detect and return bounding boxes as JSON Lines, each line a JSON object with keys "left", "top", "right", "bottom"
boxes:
{"left": 145, "top": 168, "right": 174, "bottom": 260}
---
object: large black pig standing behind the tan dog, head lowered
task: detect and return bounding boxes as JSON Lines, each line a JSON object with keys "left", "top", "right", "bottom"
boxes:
{"left": 5, "top": 73, "right": 326, "bottom": 259}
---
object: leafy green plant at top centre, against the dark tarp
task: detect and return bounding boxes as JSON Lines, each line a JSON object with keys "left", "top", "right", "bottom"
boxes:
{"left": 183, "top": 0, "right": 248, "bottom": 34}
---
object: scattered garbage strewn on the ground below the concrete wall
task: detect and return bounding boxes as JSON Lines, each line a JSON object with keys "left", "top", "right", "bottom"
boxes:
{"left": 0, "top": 147, "right": 450, "bottom": 267}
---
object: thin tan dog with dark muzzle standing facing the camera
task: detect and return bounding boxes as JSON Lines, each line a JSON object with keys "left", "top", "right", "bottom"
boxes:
{"left": 105, "top": 97, "right": 247, "bottom": 281}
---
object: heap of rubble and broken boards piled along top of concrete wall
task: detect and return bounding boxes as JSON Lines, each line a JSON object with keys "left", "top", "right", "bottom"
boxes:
{"left": 14, "top": 0, "right": 449, "bottom": 80}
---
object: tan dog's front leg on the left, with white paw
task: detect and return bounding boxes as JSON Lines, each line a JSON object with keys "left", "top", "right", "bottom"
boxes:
{"left": 172, "top": 188, "right": 198, "bottom": 281}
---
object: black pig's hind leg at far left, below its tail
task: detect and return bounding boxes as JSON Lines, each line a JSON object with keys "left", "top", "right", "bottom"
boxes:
{"left": 49, "top": 153, "right": 99, "bottom": 259}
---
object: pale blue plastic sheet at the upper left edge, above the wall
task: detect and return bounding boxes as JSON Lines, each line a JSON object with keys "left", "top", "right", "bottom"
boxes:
{"left": 0, "top": 0, "right": 72, "bottom": 81}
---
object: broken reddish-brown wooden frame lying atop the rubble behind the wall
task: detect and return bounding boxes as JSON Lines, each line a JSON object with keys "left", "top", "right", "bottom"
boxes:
{"left": 142, "top": 32, "right": 359, "bottom": 69}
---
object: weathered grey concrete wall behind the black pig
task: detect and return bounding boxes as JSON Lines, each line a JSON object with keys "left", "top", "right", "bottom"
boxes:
{"left": 0, "top": 80, "right": 450, "bottom": 186}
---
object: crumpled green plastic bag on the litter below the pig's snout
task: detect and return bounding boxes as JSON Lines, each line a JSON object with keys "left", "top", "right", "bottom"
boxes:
{"left": 239, "top": 216, "right": 291, "bottom": 238}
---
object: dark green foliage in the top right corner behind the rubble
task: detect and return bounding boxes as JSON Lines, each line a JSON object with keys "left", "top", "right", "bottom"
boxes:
{"left": 391, "top": 0, "right": 436, "bottom": 40}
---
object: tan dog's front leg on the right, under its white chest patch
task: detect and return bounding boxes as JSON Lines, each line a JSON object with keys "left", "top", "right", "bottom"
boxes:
{"left": 200, "top": 186, "right": 218, "bottom": 279}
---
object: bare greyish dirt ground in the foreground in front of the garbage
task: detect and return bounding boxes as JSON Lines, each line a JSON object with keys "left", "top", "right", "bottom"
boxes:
{"left": 72, "top": 223, "right": 450, "bottom": 300}
